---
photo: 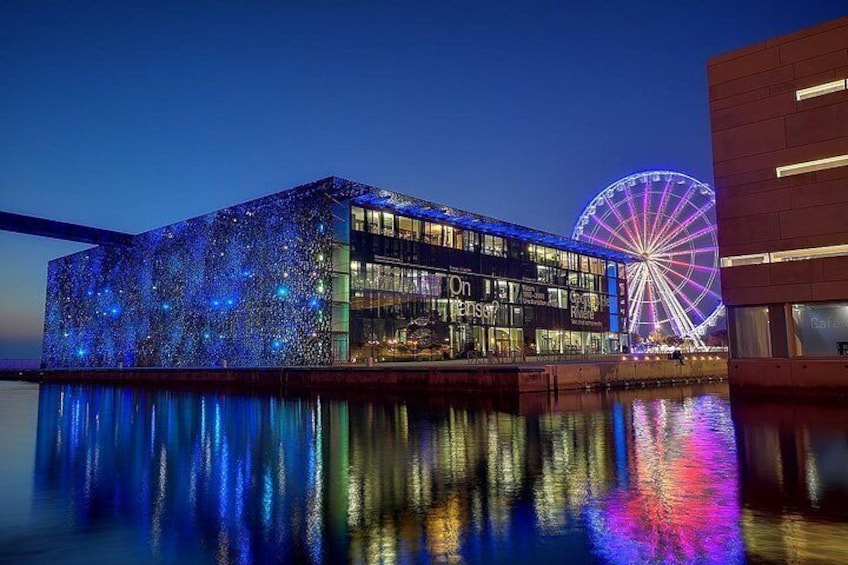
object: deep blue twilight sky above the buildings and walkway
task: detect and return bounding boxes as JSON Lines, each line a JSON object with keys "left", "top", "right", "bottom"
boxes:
{"left": 0, "top": 0, "right": 848, "bottom": 359}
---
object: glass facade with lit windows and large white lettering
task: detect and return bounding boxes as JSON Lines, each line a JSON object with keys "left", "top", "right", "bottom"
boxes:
{"left": 349, "top": 206, "right": 627, "bottom": 361}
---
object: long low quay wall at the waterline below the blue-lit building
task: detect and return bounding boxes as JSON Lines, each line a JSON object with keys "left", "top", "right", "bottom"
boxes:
{"left": 0, "top": 357, "right": 727, "bottom": 395}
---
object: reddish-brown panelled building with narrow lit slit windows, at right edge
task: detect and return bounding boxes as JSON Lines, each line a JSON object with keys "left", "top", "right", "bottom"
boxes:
{"left": 708, "top": 17, "right": 848, "bottom": 387}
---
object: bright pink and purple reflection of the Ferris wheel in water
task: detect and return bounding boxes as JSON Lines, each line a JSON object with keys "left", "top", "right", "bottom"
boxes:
{"left": 588, "top": 396, "right": 744, "bottom": 564}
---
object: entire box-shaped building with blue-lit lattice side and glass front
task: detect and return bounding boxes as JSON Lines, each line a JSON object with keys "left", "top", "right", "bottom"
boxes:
{"left": 43, "top": 177, "right": 631, "bottom": 368}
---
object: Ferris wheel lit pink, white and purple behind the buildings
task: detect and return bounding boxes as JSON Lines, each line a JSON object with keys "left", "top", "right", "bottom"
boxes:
{"left": 572, "top": 171, "right": 724, "bottom": 343}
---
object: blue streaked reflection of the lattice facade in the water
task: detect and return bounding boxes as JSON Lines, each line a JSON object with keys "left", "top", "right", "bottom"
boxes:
{"left": 35, "top": 386, "right": 323, "bottom": 562}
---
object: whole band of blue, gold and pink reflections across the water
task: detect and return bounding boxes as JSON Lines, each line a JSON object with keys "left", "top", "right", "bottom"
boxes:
{"left": 0, "top": 386, "right": 848, "bottom": 563}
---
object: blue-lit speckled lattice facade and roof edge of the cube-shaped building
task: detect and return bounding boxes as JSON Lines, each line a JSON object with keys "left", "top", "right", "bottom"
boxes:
{"left": 43, "top": 177, "right": 628, "bottom": 367}
